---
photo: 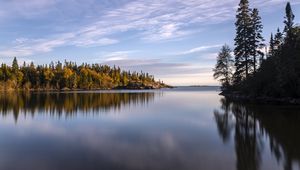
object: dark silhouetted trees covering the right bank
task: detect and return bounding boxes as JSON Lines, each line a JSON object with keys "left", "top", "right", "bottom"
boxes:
{"left": 214, "top": 0, "right": 300, "bottom": 98}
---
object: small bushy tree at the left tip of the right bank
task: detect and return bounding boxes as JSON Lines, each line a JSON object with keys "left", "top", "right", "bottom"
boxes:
{"left": 213, "top": 44, "right": 233, "bottom": 89}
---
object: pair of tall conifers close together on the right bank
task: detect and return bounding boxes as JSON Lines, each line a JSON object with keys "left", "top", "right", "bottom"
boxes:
{"left": 234, "top": 0, "right": 265, "bottom": 85}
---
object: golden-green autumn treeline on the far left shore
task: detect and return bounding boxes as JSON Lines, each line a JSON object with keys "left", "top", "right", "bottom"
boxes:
{"left": 0, "top": 58, "right": 165, "bottom": 90}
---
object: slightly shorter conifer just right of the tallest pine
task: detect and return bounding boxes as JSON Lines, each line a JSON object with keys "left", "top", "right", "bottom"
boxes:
{"left": 250, "top": 8, "right": 265, "bottom": 73}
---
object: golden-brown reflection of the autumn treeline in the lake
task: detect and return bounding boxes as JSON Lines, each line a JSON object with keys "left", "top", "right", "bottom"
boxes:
{"left": 0, "top": 92, "right": 158, "bottom": 121}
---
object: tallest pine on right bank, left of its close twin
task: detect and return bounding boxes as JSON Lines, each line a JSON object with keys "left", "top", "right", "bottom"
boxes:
{"left": 234, "top": 0, "right": 251, "bottom": 84}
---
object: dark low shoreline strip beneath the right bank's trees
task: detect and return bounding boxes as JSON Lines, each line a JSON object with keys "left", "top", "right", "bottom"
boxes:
{"left": 219, "top": 92, "right": 300, "bottom": 105}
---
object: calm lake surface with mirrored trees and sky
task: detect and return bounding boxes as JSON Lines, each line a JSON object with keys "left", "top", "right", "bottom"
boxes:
{"left": 0, "top": 87, "right": 300, "bottom": 170}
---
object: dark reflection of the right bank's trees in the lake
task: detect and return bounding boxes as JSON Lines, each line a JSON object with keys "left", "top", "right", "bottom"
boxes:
{"left": 214, "top": 98, "right": 300, "bottom": 170}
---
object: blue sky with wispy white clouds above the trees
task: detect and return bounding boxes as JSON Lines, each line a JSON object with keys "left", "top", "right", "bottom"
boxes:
{"left": 0, "top": 0, "right": 300, "bottom": 85}
